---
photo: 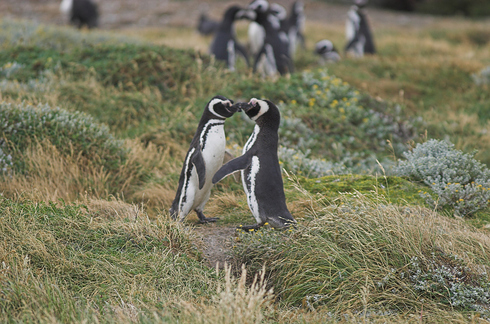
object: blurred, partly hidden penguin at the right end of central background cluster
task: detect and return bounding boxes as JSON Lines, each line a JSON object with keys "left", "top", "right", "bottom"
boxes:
{"left": 282, "top": 1, "right": 306, "bottom": 58}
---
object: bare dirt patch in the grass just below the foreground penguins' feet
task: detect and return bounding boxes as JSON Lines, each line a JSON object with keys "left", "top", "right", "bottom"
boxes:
{"left": 194, "top": 224, "right": 236, "bottom": 269}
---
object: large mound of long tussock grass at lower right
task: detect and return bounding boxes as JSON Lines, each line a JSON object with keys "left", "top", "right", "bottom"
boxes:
{"left": 234, "top": 187, "right": 490, "bottom": 314}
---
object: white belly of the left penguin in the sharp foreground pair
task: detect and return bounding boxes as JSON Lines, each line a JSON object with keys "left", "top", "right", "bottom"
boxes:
{"left": 191, "top": 125, "right": 226, "bottom": 209}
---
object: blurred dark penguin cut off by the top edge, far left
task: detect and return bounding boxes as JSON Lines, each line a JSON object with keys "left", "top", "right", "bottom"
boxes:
{"left": 60, "top": 0, "right": 99, "bottom": 28}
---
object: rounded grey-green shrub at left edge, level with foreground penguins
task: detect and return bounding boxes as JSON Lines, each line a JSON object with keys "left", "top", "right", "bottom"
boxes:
{"left": 0, "top": 102, "right": 128, "bottom": 172}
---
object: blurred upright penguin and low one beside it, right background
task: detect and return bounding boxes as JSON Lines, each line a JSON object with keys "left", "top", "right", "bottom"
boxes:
{"left": 315, "top": 0, "right": 376, "bottom": 63}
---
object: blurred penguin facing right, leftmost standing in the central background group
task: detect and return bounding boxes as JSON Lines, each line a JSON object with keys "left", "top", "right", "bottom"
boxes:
{"left": 210, "top": 6, "right": 249, "bottom": 71}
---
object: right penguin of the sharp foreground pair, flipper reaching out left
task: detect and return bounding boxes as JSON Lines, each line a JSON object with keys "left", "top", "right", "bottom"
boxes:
{"left": 213, "top": 98, "right": 296, "bottom": 230}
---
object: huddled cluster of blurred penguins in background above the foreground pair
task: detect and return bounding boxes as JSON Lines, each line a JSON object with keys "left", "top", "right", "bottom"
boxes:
{"left": 210, "top": 0, "right": 304, "bottom": 75}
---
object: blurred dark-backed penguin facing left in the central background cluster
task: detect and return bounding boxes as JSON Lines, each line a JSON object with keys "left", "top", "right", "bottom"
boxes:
{"left": 248, "top": 0, "right": 294, "bottom": 76}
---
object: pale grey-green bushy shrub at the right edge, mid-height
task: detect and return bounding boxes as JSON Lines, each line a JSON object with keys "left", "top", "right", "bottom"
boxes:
{"left": 395, "top": 139, "right": 490, "bottom": 216}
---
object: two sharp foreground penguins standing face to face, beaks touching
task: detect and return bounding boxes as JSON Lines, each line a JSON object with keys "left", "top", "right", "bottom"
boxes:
{"left": 169, "top": 96, "right": 296, "bottom": 231}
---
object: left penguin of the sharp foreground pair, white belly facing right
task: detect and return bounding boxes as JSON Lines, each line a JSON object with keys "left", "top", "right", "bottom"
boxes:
{"left": 169, "top": 96, "right": 242, "bottom": 223}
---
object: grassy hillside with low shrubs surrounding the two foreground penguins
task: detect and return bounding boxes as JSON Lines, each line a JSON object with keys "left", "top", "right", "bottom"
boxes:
{"left": 0, "top": 15, "right": 490, "bottom": 323}
